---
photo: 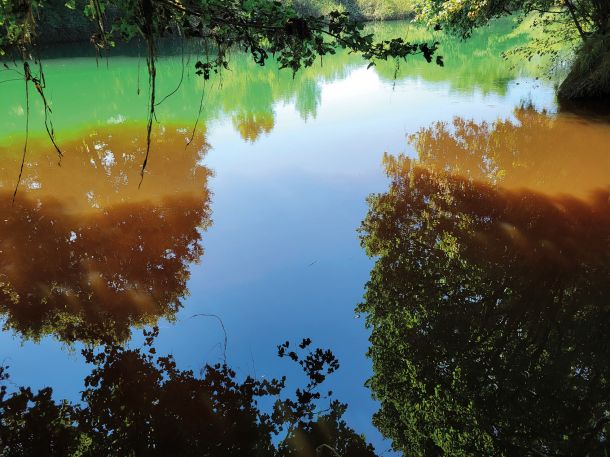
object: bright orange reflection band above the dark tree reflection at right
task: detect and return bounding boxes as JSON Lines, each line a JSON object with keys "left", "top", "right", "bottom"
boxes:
{"left": 410, "top": 108, "right": 610, "bottom": 196}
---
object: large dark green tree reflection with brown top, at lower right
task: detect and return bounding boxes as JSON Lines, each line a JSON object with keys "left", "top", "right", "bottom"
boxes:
{"left": 360, "top": 158, "right": 610, "bottom": 456}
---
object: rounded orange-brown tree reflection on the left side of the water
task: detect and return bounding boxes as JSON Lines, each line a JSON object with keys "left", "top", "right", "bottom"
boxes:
{"left": 0, "top": 124, "right": 209, "bottom": 341}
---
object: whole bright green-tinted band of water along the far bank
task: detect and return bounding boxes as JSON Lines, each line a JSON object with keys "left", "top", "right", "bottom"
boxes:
{"left": 0, "top": 21, "right": 535, "bottom": 142}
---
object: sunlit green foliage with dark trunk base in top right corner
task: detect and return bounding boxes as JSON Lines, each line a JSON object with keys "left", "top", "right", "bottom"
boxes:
{"left": 418, "top": 0, "right": 610, "bottom": 99}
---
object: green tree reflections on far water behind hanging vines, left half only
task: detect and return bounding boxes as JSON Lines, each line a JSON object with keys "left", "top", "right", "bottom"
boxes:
{"left": 0, "top": 45, "right": 338, "bottom": 142}
